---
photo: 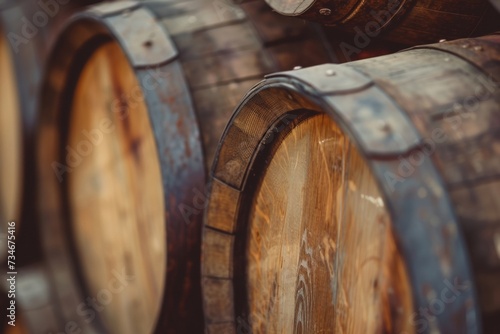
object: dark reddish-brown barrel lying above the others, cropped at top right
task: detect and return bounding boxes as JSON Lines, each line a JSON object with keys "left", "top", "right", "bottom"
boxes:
{"left": 266, "top": 0, "right": 500, "bottom": 45}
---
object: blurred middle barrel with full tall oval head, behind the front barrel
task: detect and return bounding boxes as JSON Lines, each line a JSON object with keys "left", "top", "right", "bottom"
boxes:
{"left": 38, "top": 0, "right": 336, "bottom": 334}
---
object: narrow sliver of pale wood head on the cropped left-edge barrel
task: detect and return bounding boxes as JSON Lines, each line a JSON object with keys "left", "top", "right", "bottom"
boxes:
{"left": 0, "top": 29, "right": 22, "bottom": 256}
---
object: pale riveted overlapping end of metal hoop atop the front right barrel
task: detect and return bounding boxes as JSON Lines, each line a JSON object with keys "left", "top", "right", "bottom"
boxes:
{"left": 266, "top": 64, "right": 422, "bottom": 156}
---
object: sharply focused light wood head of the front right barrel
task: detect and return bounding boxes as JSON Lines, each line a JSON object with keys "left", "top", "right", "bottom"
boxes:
{"left": 247, "top": 115, "right": 414, "bottom": 333}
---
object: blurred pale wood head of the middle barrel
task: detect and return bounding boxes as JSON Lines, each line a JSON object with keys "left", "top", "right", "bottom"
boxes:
{"left": 68, "top": 43, "right": 167, "bottom": 334}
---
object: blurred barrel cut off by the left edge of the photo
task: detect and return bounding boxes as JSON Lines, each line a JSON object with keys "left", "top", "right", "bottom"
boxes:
{"left": 0, "top": 0, "right": 99, "bottom": 265}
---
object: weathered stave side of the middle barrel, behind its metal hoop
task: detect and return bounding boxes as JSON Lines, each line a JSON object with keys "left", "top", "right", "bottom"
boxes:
{"left": 158, "top": 0, "right": 332, "bottom": 169}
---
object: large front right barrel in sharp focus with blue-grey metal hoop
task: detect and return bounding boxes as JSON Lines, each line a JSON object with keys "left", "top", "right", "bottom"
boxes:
{"left": 202, "top": 35, "right": 500, "bottom": 333}
